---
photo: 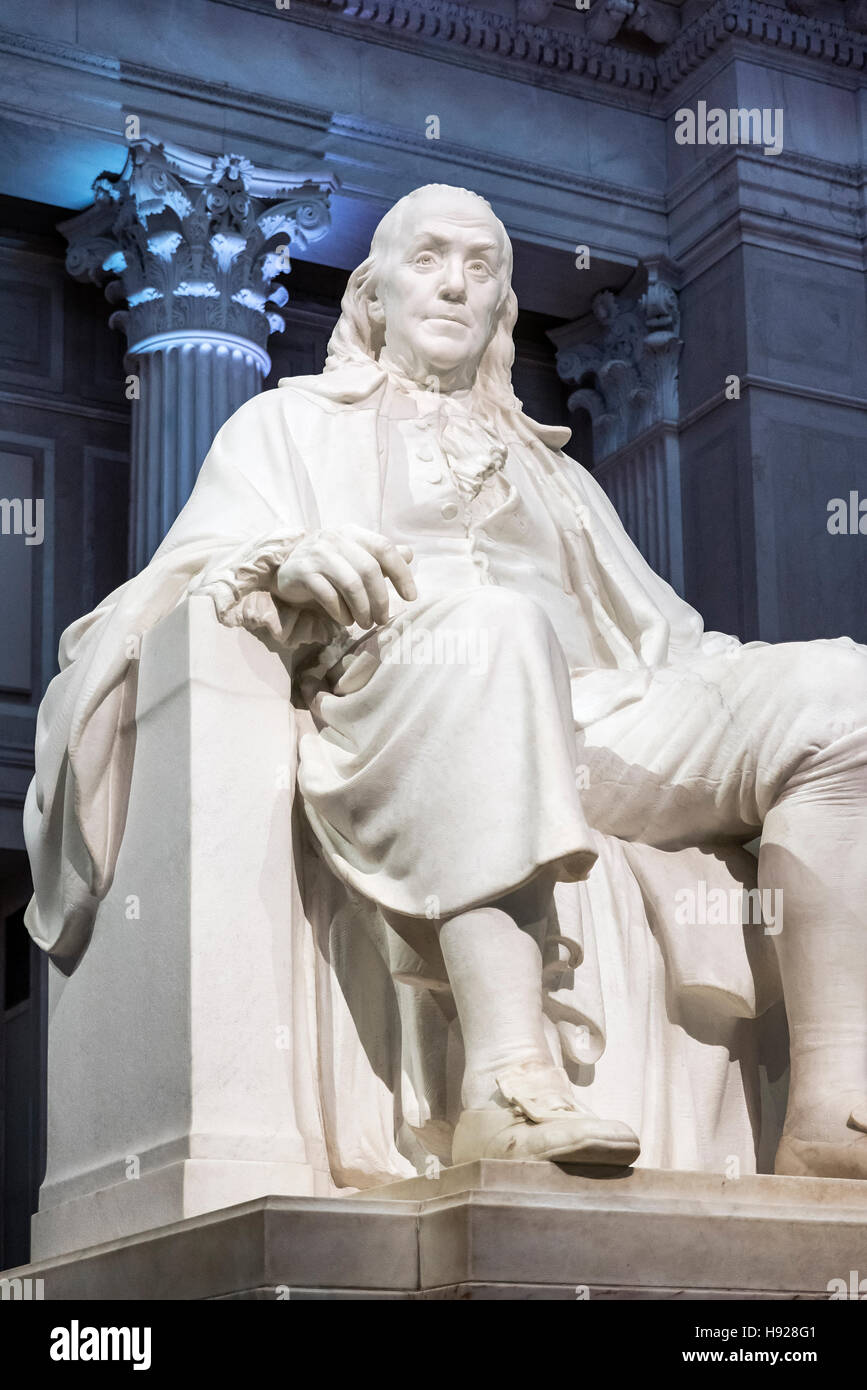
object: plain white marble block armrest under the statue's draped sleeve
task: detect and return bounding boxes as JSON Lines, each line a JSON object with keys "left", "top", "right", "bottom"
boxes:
{"left": 32, "top": 598, "right": 333, "bottom": 1259}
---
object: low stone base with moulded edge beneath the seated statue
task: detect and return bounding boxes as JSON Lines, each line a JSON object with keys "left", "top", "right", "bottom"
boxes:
{"left": 7, "top": 1161, "right": 867, "bottom": 1301}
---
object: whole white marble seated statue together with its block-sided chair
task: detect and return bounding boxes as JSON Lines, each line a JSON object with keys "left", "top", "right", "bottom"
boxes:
{"left": 25, "top": 185, "right": 867, "bottom": 1250}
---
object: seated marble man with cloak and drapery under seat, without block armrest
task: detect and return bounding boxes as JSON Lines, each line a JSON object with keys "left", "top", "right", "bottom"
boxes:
{"left": 18, "top": 185, "right": 867, "bottom": 1187}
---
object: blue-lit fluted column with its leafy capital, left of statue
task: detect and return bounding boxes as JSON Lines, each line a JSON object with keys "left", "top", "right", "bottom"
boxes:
{"left": 60, "top": 139, "right": 336, "bottom": 573}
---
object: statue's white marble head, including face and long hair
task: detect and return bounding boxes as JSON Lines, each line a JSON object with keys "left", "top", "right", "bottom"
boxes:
{"left": 327, "top": 183, "right": 518, "bottom": 407}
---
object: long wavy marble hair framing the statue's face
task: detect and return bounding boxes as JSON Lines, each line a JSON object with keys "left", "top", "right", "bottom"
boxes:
{"left": 325, "top": 183, "right": 521, "bottom": 414}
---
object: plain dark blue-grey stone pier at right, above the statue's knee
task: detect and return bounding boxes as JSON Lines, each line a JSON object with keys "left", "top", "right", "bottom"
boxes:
{"left": 679, "top": 246, "right": 867, "bottom": 642}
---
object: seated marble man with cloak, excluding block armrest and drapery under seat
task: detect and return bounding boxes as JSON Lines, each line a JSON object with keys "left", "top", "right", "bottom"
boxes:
{"left": 26, "top": 185, "right": 867, "bottom": 1177}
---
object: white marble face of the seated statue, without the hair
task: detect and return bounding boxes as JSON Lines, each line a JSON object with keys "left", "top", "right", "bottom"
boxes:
{"left": 375, "top": 193, "right": 504, "bottom": 385}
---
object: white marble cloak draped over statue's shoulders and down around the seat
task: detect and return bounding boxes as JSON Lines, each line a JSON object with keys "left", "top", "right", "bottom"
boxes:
{"left": 25, "top": 363, "right": 779, "bottom": 1187}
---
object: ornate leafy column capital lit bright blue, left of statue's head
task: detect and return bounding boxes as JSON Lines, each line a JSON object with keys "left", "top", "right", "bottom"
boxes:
{"left": 58, "top": 136, "right": 339, "bottom": 349}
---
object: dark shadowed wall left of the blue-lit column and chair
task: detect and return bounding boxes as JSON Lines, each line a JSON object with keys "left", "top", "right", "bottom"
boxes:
{"left": 0, "top": 199, "right": 129, "bottom": 1269}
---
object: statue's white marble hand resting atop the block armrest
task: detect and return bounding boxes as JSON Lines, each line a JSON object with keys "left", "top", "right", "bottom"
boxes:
{"left": 272, "top": 525, "right": 417, "bottom": 628}
